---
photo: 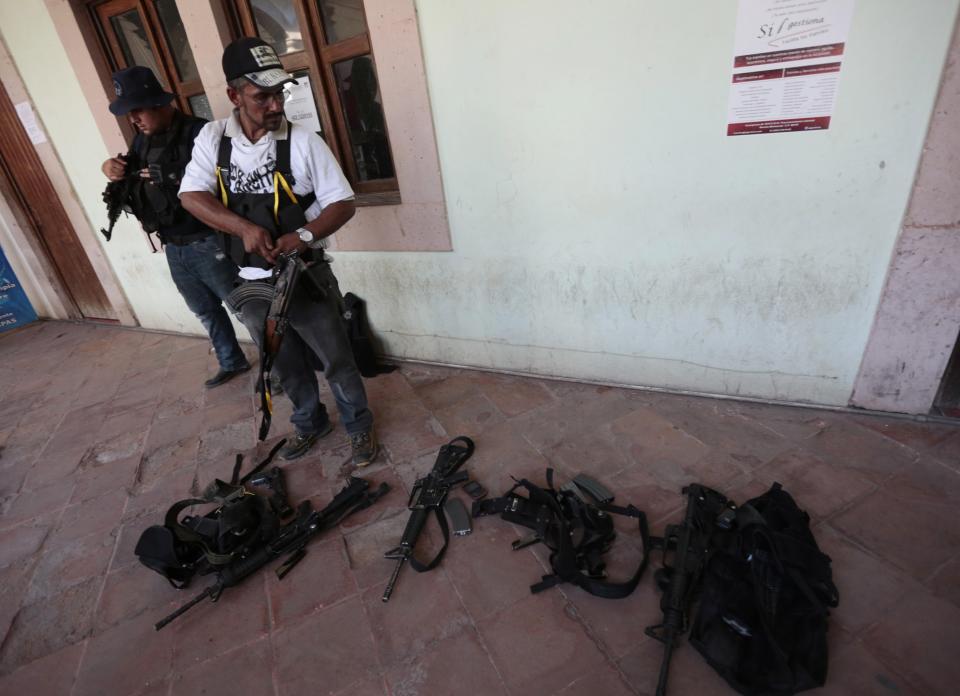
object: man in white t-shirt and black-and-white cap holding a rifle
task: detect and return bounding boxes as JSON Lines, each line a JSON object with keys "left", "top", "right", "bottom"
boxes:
{"left": 180, "top": 37, "right": 378, "bottom": 466}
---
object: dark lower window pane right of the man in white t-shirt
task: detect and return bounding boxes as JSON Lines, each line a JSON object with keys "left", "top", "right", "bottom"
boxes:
{"left": 333, "top": 55, "right": 393, "bottom": 181}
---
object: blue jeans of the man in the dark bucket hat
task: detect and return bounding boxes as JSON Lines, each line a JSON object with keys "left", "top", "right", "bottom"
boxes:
{"left": 163, "top": 235, "right": 248, "bottom": 370}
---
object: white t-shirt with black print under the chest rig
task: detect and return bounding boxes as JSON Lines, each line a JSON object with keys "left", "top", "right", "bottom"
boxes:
{"left": 180, "top": 111, "right": 353, "bottom": 222}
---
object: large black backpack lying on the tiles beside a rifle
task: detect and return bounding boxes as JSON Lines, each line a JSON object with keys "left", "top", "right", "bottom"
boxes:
{"left": 690, "top": 483, "right": 839, "bottom": 695}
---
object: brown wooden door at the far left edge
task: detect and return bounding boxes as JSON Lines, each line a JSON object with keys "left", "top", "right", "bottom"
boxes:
{"left": 0, "top": 85, "right": 117, "bottom": 321}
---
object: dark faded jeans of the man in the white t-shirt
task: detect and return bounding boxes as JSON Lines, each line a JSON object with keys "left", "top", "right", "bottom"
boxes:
{"left": 229, "top": 263, "right": 373, "bottom": 435}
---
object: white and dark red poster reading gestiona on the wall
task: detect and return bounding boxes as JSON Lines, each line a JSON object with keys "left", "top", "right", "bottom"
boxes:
{"left": 727, "top": 0, "right": 854, "bottom": 135}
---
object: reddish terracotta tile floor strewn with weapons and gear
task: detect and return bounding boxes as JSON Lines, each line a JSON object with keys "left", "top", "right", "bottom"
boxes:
{"left": 0, "top": 322, "right": 960, "bottom": 696}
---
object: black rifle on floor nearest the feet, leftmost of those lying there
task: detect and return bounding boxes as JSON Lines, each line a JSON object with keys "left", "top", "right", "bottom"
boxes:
{"left": 154, "top": 477, "right": 390, "bottom": 631}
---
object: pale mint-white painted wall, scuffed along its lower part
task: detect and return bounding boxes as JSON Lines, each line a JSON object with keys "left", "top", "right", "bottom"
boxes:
{"left": 0, "top": 0, "right": 960, "bottom": 404}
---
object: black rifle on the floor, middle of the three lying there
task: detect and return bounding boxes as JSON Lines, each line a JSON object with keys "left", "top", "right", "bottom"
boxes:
{"left": 382, "top": 436, "right": 474, "bottom": 602}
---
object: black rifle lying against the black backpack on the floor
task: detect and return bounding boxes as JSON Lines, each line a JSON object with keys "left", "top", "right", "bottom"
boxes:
{"left": 646, "top": 483, "right": 736, "bottom": 696}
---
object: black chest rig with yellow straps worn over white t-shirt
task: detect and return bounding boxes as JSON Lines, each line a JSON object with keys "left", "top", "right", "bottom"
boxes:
{"left": 217, "top": 124, "right": 317, "bottom": 268}
